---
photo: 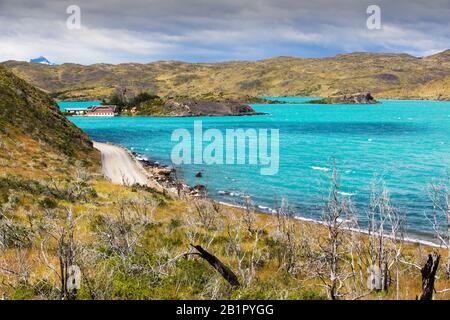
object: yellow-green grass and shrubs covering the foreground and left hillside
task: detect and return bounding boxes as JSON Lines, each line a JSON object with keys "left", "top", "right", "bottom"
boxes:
{"left": 0, "top": 64, "right": 450, "bottom": 299}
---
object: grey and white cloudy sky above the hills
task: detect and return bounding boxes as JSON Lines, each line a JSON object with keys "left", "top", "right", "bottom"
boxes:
{"left": 0, "top": 0, "right": 450, "bottom": 64}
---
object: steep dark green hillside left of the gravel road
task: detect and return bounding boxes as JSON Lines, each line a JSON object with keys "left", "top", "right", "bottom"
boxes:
{"left": 0, "top": 67, "right": 93, "bottom": 159}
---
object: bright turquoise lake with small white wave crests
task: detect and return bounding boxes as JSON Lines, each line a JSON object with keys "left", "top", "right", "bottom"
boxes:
{"left": 65, "top": 97, "right": 450, "bottom": 237}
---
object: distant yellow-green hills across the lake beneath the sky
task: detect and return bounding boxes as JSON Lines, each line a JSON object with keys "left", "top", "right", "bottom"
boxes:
{"left": 4, "top": 51, "right": 450, "bottom": 99}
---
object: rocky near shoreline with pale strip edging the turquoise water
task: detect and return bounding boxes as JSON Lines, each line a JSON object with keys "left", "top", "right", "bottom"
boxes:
{"left": 104, "top": 144, "right": 445, "bottom": 248}
